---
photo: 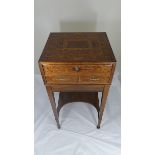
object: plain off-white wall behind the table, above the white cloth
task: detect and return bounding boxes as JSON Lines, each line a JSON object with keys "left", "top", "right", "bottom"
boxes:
{"left": 34, "top": 0, "right": 121, "bottom": 79}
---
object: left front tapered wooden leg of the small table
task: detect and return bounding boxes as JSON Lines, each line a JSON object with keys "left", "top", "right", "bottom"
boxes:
{"left": 46, "top": 86, "right": 60, "bottom": 129}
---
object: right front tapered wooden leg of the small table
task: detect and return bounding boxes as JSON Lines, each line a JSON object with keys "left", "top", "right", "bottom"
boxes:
{"left": 97, "top": 85, "right": 110, "bottom": 129}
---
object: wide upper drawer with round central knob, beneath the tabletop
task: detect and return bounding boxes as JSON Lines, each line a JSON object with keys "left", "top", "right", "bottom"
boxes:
{"left": 43, "top": 64, "right": 112, "bottom": 76}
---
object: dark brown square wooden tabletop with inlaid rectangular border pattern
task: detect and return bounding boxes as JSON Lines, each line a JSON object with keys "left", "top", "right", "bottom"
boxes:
{"left": 39, "top": 32, "right": 116, "bottom": 62}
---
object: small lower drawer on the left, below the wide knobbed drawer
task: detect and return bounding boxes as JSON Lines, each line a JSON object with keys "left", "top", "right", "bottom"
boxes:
{"left": 45, "top": 75, "right": 79, "bottom": 84}
